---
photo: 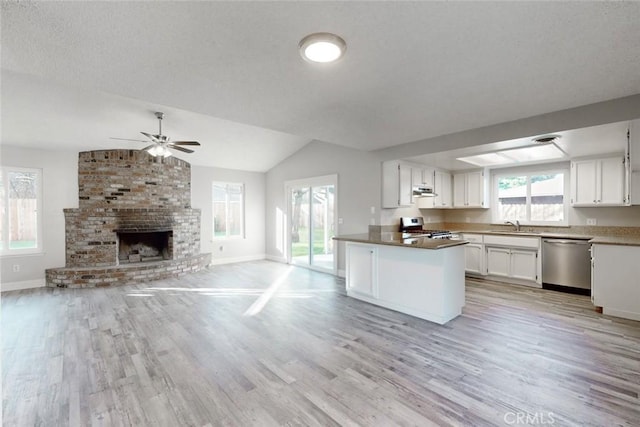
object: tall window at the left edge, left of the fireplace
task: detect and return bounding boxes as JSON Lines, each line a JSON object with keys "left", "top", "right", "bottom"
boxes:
{"left": 0, "top": 167, "right": 42, "bottom": 255}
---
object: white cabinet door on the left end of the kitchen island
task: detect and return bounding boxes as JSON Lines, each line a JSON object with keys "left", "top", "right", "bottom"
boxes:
{"left": 346, "top": 244, "right": 378, "bottom": 297}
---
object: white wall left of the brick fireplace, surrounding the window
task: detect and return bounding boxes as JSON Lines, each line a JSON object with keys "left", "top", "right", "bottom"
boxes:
{"left": 0, "top": 146, "right": 78, "bottom": 290}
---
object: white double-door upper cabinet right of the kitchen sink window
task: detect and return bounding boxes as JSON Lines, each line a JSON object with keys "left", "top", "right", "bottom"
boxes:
{"left": 571, "top": 155, "right": 628, "bottom": 207}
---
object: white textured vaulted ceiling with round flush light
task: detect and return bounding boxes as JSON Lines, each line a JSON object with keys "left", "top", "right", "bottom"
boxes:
{"left": 1, "top": 2, "right": 640, "bottom": 170}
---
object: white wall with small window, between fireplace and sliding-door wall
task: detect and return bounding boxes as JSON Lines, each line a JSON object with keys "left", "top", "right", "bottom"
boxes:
{"left": 191, "top": 166, "right": 265, "bottom": 264}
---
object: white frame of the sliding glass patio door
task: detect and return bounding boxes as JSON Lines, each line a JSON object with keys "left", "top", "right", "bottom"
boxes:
{"left": 284, "top": 175, "right": 338, "bottom": 275}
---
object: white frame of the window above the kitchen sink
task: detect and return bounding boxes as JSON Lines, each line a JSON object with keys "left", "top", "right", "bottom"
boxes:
{"left": 491, "top": 165, "right": 571, "bottom": 227}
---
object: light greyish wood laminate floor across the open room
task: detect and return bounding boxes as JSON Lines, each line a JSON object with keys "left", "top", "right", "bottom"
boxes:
{"left": 2, "top": 261, "right": 640, "bottom": 426}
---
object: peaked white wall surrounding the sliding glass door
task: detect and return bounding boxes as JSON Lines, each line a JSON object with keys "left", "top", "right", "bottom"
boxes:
{"left": 266, "top": 141, "right": 381, "bottom": 270}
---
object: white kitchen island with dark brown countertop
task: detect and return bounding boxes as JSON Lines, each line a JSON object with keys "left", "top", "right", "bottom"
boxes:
{"left": 334, "top": 233, "right": 467, "bottom": 325}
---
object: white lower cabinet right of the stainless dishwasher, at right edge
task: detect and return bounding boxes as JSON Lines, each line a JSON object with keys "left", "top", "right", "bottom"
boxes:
{"left": 591, "top": 244, "right": 640, "bottom": 320}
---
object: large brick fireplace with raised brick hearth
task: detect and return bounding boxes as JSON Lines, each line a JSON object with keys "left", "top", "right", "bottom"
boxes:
{"left": 46, "top": 150, "right": 211, "bottom": 287}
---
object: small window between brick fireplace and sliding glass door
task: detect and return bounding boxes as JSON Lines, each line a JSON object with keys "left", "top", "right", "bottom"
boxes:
{"left": 213, "top": 182, "right": 244, "bottom": 239}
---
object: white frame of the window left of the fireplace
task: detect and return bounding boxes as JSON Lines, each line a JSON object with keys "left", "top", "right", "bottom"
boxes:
{"left": 0, "top": 166, "right": 44, "bottom": 258}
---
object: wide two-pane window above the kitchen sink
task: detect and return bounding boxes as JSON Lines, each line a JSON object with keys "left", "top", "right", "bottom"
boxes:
{"left": 493, "top": 171, "right": 568, "bottom": 225}
